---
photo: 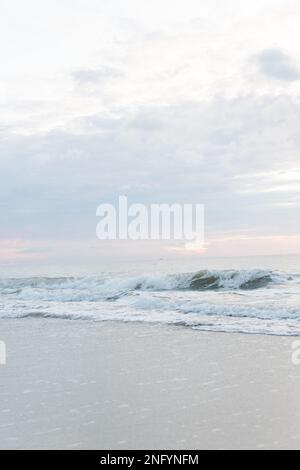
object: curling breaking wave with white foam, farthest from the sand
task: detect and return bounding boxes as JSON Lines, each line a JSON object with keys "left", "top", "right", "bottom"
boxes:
{"left": 0, "top": 269, "right": 293, "bottom": 300}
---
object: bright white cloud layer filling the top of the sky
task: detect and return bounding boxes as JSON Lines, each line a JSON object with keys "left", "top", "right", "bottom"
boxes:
{"left": 0, "top": 0, "right": 300, "bottom": 134}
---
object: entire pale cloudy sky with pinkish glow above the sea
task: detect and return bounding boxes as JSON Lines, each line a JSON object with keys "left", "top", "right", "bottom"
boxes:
{"left": 0, "top": 0, "right": 300, "bottom": 265}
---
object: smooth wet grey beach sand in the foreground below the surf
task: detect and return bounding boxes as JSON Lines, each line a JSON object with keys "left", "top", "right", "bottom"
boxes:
{"left": 0, "top": 318, "right": 300, "bottom": 449}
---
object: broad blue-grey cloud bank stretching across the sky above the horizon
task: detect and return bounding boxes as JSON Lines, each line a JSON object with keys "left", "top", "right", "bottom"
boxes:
{"left": 0, "top": 95, "right": 300, "bottom": 252}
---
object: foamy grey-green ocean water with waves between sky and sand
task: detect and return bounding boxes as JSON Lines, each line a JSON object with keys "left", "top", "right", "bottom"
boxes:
{"left": 0, "top": 255, "right": 300, "bottom": 336}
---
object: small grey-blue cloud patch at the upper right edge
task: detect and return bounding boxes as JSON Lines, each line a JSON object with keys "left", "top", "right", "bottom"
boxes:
{"left": 256, "top": 49, "right": 300, "bottom": 81}
